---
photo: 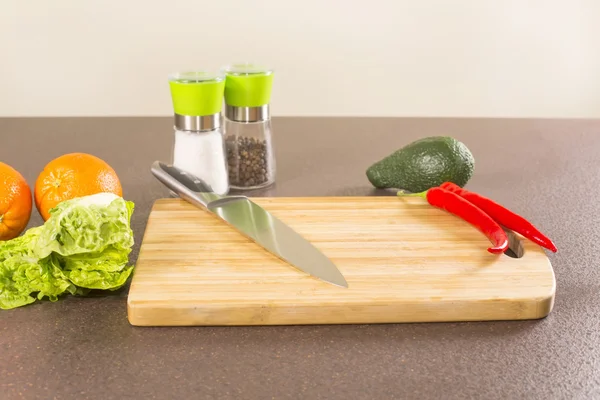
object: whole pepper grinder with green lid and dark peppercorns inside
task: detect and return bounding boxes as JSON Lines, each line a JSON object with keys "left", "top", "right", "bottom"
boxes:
{"left": 223, "top": 64, "right": 276, "bottom": 189}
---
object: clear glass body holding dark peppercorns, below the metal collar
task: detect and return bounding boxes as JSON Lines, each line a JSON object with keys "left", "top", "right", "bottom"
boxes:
{"left": 225, "top": 117, "right": 276, "bottom": 190}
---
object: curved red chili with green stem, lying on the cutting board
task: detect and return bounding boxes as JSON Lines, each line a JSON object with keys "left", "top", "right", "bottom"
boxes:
{"left": 398, "top": 187, "right": 508, "bottom": 254}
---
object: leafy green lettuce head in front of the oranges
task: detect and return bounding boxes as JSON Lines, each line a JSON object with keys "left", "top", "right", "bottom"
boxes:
{"left": 0, "top": 193, "right": 134, "bottom": 309}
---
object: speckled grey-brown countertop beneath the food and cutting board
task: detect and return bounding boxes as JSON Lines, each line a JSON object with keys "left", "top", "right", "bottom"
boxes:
{"left": 0, "top": 118, "right": 600, "bottom": 400}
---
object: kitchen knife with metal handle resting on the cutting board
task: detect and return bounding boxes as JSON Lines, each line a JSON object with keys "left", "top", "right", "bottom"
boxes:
{"left": 151, "top": 161, "right": 348, "bottom": 287}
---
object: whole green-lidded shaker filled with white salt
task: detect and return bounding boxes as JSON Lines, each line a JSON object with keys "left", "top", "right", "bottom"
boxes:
{"left": 169, "top": 71, "right": 229, "bottom": 195}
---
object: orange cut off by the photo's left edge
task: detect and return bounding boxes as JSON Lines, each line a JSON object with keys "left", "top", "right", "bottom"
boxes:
{"left": 0, "top": 162, "right": 32, "bottom": 240}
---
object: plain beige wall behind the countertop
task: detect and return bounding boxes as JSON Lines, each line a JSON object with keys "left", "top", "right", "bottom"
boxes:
{"left": 0, "top": 0, "right": 600, "bottom": 117}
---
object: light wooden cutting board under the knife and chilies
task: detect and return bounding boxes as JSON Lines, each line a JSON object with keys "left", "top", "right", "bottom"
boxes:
{"left": 127, "top": 196, "right": 555, "bottom": 326}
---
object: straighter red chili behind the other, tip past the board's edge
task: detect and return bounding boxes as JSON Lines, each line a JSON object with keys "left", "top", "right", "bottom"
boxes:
{"left": 440, "top": 182, "right": 557, "bottom": 253}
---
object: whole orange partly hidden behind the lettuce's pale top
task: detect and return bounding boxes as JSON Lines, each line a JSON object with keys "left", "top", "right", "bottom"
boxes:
{"left": 34, "top": 153, "right": 123, "bottom": 221}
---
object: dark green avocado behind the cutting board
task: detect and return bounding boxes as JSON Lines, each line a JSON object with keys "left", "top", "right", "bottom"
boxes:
{"left": 367, "top": 136, "right": 475, "bottom": 193}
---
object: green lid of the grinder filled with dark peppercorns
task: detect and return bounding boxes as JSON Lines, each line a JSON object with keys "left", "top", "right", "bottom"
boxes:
{"left": 225, "top": 63, "right": 273, "bottom": 107}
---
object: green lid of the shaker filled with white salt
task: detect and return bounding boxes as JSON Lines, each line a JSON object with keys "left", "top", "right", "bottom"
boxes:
{"left": 169, "top": 71, "right": 225, "bottom": 117}
